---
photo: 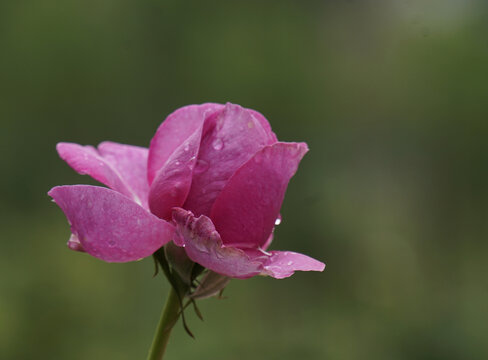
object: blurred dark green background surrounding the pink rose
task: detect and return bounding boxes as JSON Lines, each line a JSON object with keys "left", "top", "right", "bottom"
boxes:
{"left": 0, "top": 0, "right": 488, "bottom": 360}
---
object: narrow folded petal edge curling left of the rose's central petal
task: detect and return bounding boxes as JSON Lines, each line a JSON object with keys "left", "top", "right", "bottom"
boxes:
{"left": 149, "top": 122, "right": 203, "bottom": 220}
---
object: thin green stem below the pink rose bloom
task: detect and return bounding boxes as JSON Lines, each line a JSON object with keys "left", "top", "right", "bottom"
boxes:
{"left": 147, "top": 287, "right": 180, "bottom": 360}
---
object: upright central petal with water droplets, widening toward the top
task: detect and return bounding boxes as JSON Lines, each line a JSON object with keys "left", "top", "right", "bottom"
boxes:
{"left": 184, "top": 103, "right": 276, "bottom": 216}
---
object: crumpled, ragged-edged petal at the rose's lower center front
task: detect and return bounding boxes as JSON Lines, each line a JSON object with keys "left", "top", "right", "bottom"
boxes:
{"left": 173, "top": 208, "right": 264, "bottom": 279}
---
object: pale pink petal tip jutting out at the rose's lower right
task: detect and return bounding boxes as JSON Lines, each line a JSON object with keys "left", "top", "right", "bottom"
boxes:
{"left": 263, "top": 251, "right": 325, "bottom": 279}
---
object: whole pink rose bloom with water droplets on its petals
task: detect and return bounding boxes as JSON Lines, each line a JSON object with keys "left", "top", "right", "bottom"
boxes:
{"left": 49, "top": 104, "right": 325, "bottom": 278}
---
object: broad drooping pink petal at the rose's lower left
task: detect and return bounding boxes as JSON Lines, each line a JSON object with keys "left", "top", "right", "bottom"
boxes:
{"left": 48, "top": 185, "right": 174, "bottom": 262}
